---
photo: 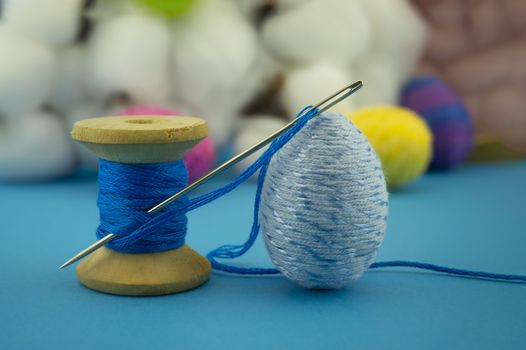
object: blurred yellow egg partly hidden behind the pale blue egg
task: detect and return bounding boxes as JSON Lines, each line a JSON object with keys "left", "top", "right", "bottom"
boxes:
{"left": 347, "top": 106, "right": 433, "bottom": 188}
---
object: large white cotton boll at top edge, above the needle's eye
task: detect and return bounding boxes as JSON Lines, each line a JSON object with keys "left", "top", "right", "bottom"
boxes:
{"left": 262, "top": 0, "right": 371, "bottom": 64}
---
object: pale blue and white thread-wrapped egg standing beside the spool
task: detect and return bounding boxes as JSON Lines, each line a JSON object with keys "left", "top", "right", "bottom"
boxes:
{"left": 260, "top": 113, "right": 387, "bottom": 289}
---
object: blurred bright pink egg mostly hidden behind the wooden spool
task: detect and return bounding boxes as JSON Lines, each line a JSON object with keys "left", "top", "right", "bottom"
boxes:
{"left": 120, "top": 106, "right": 216, "bottom": 183}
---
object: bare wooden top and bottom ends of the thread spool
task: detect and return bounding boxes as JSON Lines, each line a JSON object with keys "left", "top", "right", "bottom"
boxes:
{"left": 71, "top": 116, "right": 211, "bottom": 296}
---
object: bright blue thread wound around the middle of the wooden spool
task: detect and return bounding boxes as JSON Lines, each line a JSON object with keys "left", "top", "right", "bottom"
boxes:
{"left": 97, "top": 159, "right": 189, "bottom": 253}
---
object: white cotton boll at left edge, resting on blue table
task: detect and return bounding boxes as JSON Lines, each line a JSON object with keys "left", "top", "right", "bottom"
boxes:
{"left": 0, "top": 112, "right": 75, "bottom": 181}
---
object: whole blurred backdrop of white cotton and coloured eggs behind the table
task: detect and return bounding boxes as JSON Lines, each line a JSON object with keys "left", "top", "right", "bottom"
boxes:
{"left": 0, "top": 0, "right": 526, "bottom": 188}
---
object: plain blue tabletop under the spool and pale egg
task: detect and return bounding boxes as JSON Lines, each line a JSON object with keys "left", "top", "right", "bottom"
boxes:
{"left": 0, "top": 162, "right": 526, "bottom": 350}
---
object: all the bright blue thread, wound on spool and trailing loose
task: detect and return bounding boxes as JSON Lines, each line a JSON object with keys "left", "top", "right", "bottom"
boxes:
{"left": 96, "top": 106, "right": 526, "bottom": 282}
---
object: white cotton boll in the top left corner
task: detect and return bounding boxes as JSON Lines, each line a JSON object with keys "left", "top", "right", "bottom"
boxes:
{"left": 3, "top": 0, "right": 83, "bottom": 45}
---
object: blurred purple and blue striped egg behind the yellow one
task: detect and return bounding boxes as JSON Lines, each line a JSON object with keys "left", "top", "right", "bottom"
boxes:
{"left": 401, "top": 76, "right": 473, "bottom": 170}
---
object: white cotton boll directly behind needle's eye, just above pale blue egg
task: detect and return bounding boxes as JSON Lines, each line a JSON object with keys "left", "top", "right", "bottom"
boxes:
{"left": 281, "top": 62, "right": 353, "bottom": 118}
